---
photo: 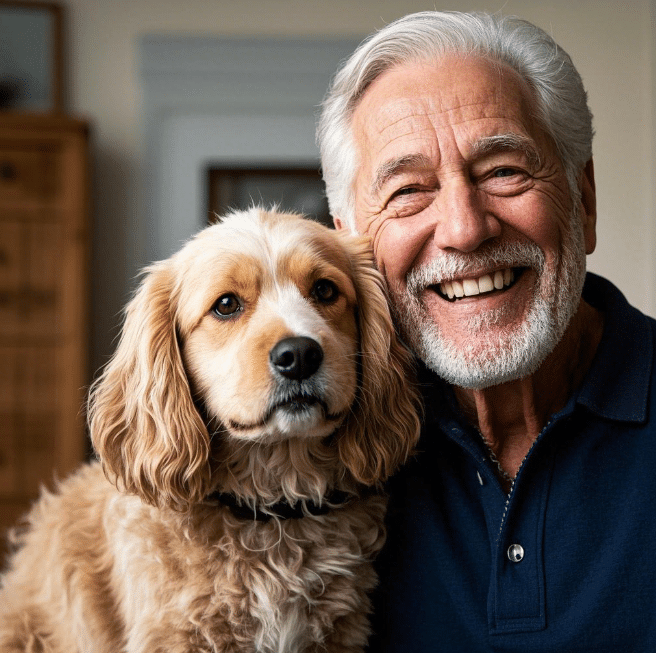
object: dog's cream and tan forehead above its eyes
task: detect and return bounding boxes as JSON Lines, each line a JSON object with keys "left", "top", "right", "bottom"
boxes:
{"left": 173, "top": 220, "right": 350, "bottom": 333}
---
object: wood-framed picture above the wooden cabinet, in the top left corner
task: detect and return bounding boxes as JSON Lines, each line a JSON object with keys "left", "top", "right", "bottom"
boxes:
{"left": 0, "top": 0, "right": 63, "bottom": 113}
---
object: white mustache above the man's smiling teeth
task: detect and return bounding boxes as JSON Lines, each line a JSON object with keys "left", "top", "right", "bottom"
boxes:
{"left": 406, "top": 243, "right": 545, "bottom": 297}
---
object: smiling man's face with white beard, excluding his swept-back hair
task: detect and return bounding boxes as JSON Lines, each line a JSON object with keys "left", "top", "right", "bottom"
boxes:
{"left": 353, "top": 57, "right": 594, "bottom": 388}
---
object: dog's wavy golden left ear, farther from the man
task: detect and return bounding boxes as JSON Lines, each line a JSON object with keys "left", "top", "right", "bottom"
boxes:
{"left": 89, "top": 262, "right": 209, "bottom": 510}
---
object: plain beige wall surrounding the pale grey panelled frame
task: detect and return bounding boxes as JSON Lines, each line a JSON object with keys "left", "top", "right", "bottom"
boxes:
{"left": 59, "top": 0, "right": 656, "bottom": 370}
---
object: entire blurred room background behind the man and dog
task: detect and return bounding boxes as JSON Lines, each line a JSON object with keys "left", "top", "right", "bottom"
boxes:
{"left": 0, "top": 0, "right": 656, "bottom": 552}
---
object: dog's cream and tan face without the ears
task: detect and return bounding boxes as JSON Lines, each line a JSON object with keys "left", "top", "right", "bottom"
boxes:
{"left": 173, "top": 213, "right": 358, "bottom": 442}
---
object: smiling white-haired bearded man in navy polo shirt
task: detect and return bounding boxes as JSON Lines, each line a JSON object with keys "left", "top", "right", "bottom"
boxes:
{"left": 319, "top": 12, "right": 656, "bottom": 653}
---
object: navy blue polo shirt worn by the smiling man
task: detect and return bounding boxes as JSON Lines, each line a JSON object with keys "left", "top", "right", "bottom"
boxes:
{"left": 369, "top": 274, "right": 656, "bottom": 653}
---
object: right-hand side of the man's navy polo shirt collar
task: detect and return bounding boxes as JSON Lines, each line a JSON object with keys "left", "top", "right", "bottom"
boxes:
{"left": 577, "top": 273, "right": 654, "bottom": 423}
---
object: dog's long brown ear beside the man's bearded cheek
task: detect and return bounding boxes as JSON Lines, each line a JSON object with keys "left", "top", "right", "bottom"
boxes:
{"left": 338, "top": 232, "right": 420, "bottom": 485}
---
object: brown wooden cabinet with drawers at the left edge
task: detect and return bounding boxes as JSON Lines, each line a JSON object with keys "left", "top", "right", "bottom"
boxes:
{"left": 0, "top": 113, "right": 89, "bottom": 550}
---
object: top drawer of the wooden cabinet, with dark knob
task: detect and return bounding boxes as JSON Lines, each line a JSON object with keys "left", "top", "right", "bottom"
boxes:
{"left": 0, "top": 142, "right": 57, "bottom": 202}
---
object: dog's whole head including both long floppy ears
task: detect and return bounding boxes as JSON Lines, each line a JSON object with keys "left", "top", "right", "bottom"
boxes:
{"left": 89, "top": 209, "right": 419, "bottom": 509}
